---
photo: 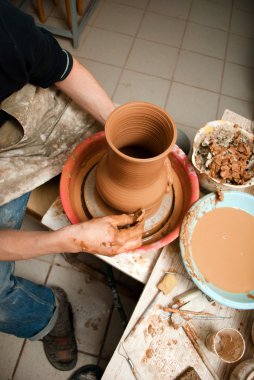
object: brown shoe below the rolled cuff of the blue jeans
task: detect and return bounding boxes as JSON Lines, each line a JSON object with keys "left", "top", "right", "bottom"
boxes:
{"left": 42, "top": 287, "right": 78, "bottom": 371}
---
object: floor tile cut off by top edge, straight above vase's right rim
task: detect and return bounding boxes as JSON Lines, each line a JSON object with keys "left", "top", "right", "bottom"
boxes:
{"left": 148, "top": 0, "right": 191, "bottom": 19}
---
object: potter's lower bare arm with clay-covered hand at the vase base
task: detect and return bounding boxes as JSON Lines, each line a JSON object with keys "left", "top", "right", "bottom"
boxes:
{"left": 0, "top": 214, "right": 144, "bottom": 261}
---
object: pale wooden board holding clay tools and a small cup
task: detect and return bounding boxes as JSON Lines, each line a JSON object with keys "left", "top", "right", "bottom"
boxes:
{"left": 102, "top": 243, "right": 254, "bottom": 380}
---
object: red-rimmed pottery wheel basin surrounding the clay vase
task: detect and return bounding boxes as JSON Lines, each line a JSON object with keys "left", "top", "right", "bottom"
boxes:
{"left": 60, "top": 132, "right": 199, "bottom": 252}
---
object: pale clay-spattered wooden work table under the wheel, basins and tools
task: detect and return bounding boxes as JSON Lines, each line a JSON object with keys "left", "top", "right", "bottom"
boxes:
{"left": 38, "top": 110, "right": 254, "bottom": 380}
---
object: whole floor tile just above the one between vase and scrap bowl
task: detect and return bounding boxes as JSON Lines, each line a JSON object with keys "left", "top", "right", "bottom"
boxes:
{"left": 174, "top": 51, "right": 223, "bottom": 92}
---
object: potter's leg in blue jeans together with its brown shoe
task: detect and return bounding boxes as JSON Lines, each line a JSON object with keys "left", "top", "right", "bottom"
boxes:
{"left": 0, "top": 194, "right": 77, "bottom": 371}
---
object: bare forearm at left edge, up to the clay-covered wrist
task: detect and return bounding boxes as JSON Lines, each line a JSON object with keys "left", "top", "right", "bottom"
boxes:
{"left": 0, "top": 230, "right": 68, "bottom": 261}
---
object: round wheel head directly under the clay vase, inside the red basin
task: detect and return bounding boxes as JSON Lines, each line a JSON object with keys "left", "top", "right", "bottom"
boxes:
{"left": 81, "top": 165, "right": 173, "bottom": 239}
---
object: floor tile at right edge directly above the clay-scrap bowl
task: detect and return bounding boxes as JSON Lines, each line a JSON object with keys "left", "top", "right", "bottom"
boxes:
{"left": 217, "top": 95, "right": 254, "bottom": 120}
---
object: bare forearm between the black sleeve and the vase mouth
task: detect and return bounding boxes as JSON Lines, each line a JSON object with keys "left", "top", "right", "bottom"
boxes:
{"left": 56, "top": 58, "right": 114, "bottom": 125}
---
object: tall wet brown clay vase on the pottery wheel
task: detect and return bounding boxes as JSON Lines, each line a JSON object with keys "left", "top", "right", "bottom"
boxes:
{"left": 96, "top": 102, "right": 176, "bottom": 217}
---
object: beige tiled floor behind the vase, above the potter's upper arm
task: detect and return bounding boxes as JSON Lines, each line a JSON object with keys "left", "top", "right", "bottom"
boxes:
{"left": 44, "top": 0, "right": 254, "bottom": 140}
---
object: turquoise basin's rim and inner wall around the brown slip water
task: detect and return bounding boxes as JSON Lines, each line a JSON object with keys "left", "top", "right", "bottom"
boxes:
{"left": 180, "top": 191, "right": 254, "bottom": 310}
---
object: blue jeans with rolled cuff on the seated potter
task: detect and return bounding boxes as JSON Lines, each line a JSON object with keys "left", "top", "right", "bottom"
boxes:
{"left": 0, "top": 194, "right": 58, "bottom": 340}
